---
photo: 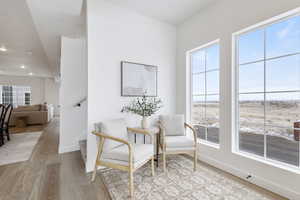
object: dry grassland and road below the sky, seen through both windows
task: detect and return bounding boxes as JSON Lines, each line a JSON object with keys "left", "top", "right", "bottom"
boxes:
{"left": 192, "top": 101, "right": 300, "bottom": 166}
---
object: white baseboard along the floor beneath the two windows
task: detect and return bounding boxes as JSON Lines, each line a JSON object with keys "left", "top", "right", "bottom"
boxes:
{"left": 198, "top": 155, "right": 300, "bottom": 200}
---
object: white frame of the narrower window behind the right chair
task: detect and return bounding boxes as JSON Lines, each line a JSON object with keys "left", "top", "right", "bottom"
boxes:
{"left": 186, "top": 39, "right": 221, "bottom": 149}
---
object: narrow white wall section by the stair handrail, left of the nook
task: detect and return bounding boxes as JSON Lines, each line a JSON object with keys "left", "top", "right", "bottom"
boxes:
{"left": 59, "top": 37, "right": 87, "bottom": 153}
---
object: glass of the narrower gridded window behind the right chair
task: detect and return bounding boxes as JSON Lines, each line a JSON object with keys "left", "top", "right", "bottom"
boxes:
{"left": 189, "top": 41, "right": 219, "bottom": 144}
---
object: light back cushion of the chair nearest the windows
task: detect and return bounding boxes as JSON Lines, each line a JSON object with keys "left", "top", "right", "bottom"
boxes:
{"left": 159, "top": 115, "right": 185, "bottom": 136}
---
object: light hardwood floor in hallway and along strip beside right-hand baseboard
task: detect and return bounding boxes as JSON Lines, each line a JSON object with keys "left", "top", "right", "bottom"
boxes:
{"left": 0, "top": 119, "right": 285, "bottom": 200}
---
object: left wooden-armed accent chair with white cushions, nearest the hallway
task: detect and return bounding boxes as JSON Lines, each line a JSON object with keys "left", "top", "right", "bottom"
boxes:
{"left": 92, "top": 119, "right": 154, "bottom": 197}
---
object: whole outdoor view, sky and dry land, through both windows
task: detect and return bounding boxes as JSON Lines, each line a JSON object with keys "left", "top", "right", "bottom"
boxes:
{"left": 191, "top": 16, "right": 300, "bottom": 170}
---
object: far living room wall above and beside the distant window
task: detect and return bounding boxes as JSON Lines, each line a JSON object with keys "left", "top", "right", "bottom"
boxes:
{"left": 0, "top": 75, "right": 45, "bottom": 104}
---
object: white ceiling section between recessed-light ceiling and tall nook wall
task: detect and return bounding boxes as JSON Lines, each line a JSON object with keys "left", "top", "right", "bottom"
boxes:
{"left": 26, "top": 0, "right": 85, "bottom": 76}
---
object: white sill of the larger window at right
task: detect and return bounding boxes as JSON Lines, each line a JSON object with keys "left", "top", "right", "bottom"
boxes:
{"left": 232, "top": 151, "right": 300, "bottom": 174}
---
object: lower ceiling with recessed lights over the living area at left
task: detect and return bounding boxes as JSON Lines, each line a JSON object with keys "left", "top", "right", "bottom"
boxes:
{"left": 0, "top": 0, "right": 52, "bottom": 76}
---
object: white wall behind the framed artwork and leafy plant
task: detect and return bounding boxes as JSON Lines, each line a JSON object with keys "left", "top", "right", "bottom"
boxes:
{"left": 86, "top": 0, "right": 176, "bottom": 171}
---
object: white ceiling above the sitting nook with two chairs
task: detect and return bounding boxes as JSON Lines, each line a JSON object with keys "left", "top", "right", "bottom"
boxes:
{"left": 108, "top": 0, "right": 217, "bottom": 25}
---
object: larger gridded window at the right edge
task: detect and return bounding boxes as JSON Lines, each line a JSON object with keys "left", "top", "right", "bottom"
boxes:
{"left": 235, "top": 13, "right": 300, "bottom": 167}
